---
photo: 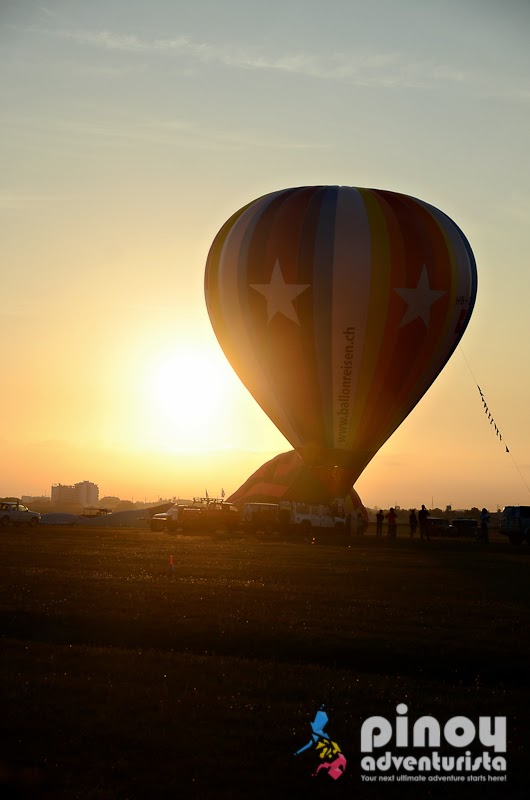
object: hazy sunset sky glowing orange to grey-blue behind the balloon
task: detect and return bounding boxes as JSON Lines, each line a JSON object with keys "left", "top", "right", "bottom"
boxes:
{"left": 0, "top": 0, "right": 530, "bottom": 509}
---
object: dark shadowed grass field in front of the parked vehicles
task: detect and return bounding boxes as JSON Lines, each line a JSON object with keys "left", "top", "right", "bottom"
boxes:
{"left": 0, "top": 526, "right": 530, "bottom": 800}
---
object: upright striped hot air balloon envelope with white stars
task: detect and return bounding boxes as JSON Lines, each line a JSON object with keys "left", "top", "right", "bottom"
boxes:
{"left": 205, "top": 186, "right": 477, "bottom": 493}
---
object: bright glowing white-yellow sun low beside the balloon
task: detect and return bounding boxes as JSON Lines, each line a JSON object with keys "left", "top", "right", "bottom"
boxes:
{"left": 144, "top": 343, "right": 233, "bottom": 450}
